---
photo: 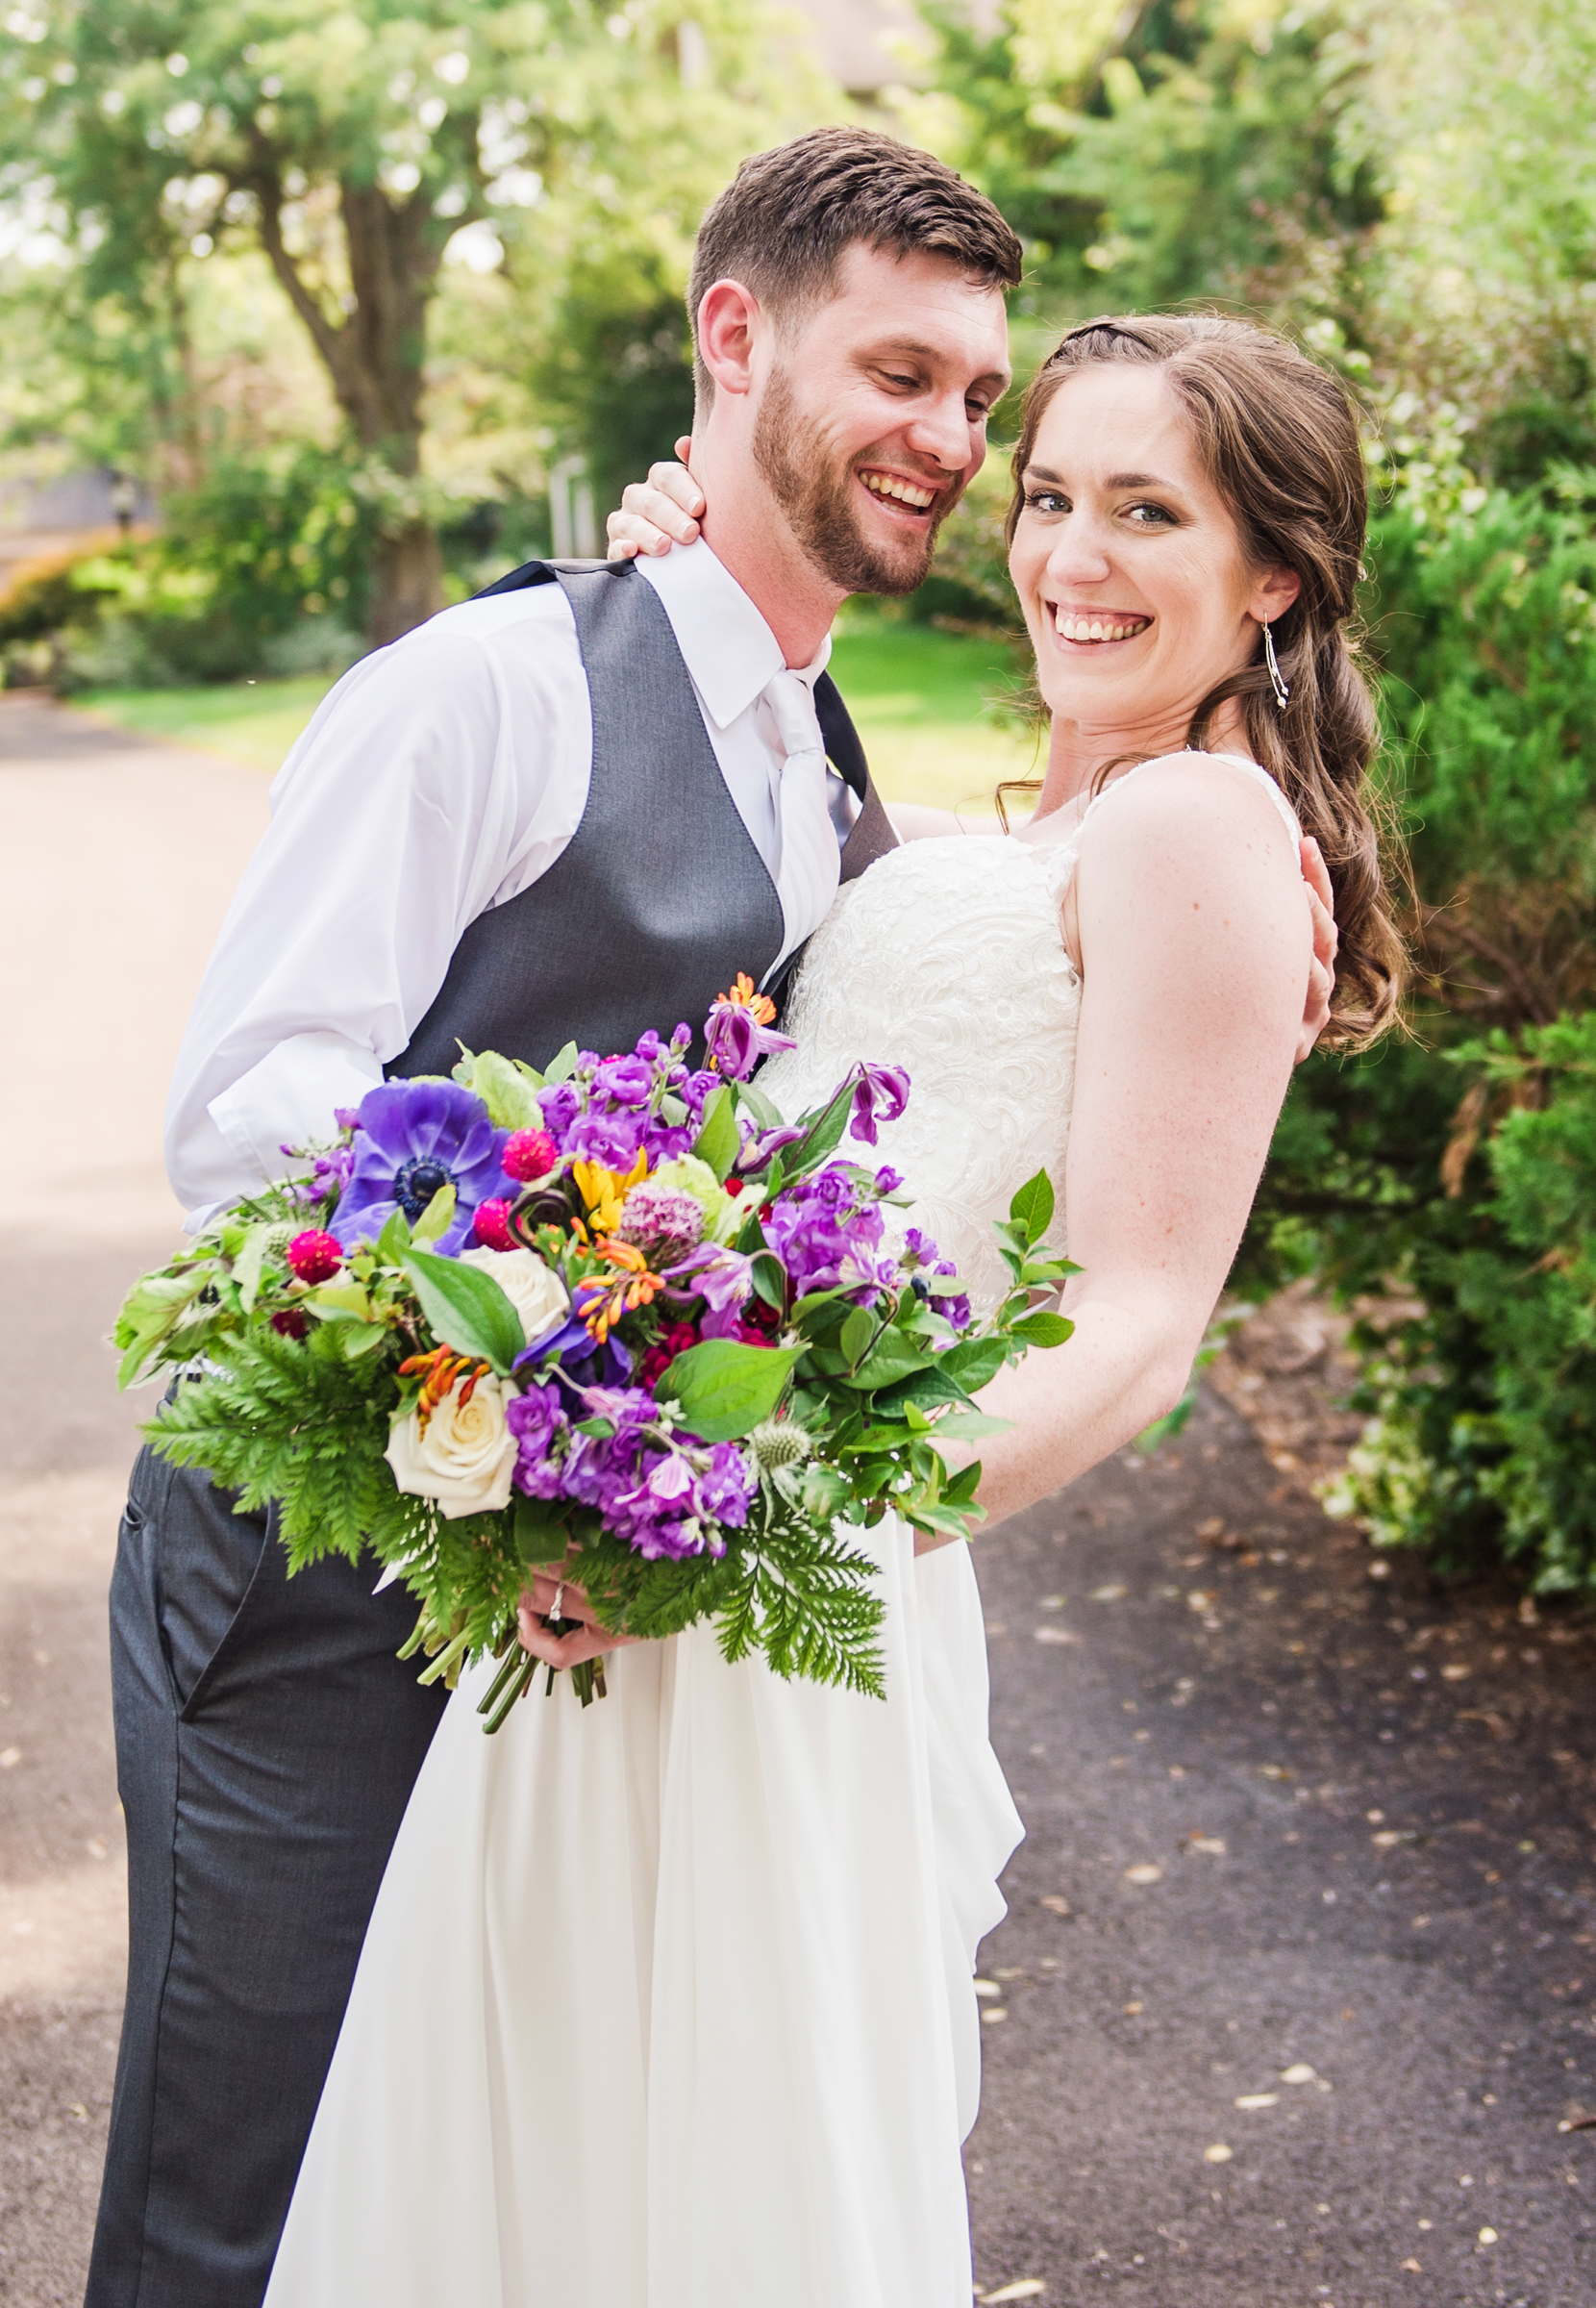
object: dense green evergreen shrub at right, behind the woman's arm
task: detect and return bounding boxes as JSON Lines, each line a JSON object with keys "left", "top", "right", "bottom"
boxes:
{"left": 1236, "top": 466, "right": 1596, "bottom": 1593}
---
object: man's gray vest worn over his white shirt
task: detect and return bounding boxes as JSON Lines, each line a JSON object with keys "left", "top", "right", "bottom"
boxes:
{"left": 387, "top": 561, "right": 895, "bottom": 1075}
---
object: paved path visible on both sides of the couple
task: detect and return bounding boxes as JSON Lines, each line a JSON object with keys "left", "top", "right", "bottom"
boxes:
{"left": 0, "top": 702, "right": 1596, "bottom": 2308}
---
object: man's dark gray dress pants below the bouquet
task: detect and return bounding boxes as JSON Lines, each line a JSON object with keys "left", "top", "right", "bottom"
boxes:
{"left": 86, "top": 1449, "right": 447, "bottom": 2308}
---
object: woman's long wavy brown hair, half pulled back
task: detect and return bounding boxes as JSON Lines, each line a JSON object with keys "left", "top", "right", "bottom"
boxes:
{"left": 1006, "top": 314, "right": 1402, "bottom": 1048}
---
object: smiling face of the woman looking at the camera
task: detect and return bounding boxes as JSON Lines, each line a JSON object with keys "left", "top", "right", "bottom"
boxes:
{"left": 1008, "top": 363, "right": 1299, "bottom": 750}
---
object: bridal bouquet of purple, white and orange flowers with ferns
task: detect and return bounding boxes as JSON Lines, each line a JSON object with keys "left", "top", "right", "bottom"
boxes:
{"left": 115, "top": 979, "right": 1072, "bottom": 1731}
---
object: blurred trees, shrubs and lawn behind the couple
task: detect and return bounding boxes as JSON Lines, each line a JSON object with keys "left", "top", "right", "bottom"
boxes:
{"left": 0, "top": 0, "right": 1596, "bottom": 1594}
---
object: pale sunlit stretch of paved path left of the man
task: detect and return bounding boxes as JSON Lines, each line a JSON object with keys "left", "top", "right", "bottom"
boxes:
{"left": 0, "top": 697, "right": 265, "bottom": 2308}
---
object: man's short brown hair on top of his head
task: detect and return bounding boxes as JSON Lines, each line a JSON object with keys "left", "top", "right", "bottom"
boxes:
{"left": 687, "top": 129, "right": 1024, "bottom": 406}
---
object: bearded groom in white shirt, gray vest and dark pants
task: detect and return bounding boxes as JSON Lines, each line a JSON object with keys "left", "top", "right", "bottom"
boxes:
{"left": 87, "top": 129, "right": 1022, "bottom": 2308}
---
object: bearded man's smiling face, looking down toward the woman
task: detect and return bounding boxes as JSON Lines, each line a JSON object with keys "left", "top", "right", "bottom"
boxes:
{"left": 754, "top": 244, "right": 1010, "bottom": 593}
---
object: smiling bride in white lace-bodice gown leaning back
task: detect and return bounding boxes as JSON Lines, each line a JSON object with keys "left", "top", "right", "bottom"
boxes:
{"left": 267, "top": 318, "right": 1395, "bottom": 2308}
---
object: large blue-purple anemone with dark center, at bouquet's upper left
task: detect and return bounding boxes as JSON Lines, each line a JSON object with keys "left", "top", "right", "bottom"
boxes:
{"left": 328, "top": 1080, "right": 516, "bottom": 1258}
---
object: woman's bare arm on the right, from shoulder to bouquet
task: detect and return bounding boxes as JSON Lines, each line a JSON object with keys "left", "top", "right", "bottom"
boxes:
{"left": 940, "top": 755, "right": 1312, "bottom": 1523}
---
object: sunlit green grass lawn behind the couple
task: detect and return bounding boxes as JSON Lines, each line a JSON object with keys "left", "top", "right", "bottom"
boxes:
{"left": 76, "top": 610, "right": 1037, "bottom": 810}
